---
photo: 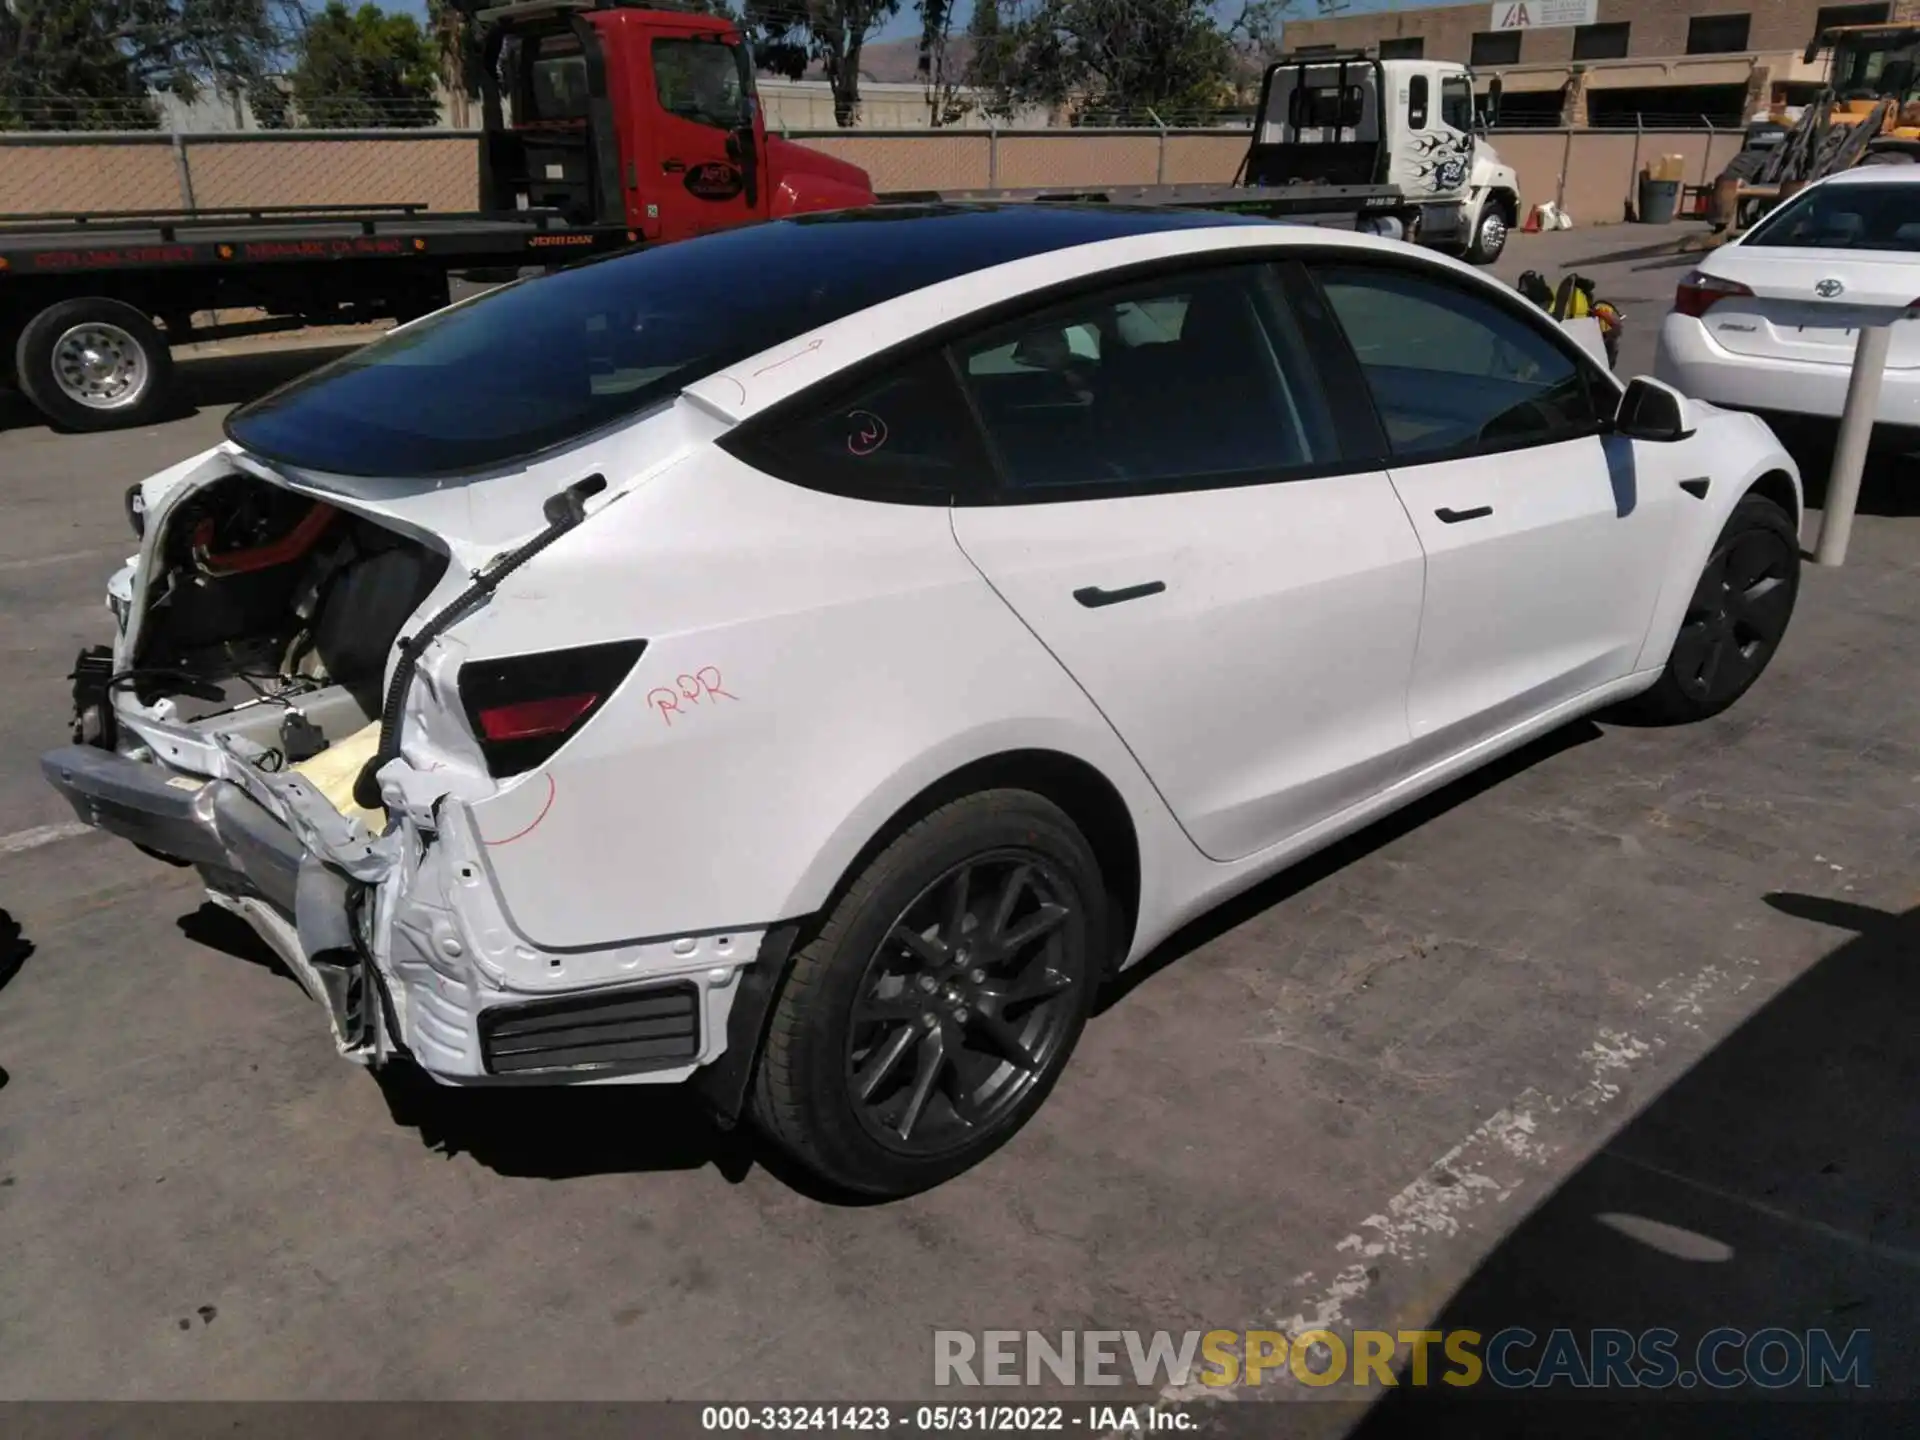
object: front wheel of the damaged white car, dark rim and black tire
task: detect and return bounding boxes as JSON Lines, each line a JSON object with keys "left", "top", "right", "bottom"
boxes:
{"left": 1622, "top": 493, "right": 1799, "bottom": 726}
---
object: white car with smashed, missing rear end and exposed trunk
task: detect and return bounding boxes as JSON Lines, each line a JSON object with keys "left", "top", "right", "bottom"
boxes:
{"left": 44, "top": 205, "right": 1801, "bottom": 1194}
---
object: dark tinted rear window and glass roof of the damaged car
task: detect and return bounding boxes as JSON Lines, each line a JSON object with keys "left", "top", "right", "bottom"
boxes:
{"left": 227, "top": 205, "right": 1274, "bottom": 476}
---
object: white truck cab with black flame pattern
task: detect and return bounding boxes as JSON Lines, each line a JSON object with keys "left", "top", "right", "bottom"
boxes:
{"left": 1246, "top": 50, "right": 1521, "bottom": 265}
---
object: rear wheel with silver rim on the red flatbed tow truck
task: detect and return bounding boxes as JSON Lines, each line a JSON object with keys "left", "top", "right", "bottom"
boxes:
{"left": 13, "top": 296, "right": 173, "bottom": 430}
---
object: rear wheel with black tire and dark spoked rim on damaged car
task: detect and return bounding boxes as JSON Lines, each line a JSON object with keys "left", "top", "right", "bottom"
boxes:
{"left": 753, "top": 789, "right": 1110, "bottom": 1196}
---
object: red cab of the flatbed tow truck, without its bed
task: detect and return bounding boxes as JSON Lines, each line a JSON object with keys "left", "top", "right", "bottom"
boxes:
{"left": 470, "top": 0, "right": 874, "bottom": 242}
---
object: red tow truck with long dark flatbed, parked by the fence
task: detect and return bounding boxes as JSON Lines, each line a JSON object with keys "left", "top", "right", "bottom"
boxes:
{"left": 0, "top": 0, "right": 874, "bottom": 430}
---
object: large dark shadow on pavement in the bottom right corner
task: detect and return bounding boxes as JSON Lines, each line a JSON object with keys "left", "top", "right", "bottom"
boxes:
{"left": 1352, "top": 895, "right": 1920, "bottom": 1440}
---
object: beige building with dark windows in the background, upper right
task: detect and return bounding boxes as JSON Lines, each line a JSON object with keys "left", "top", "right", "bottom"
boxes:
{"left": 1283, "top": 0, "right": 1920, "bottom": 129}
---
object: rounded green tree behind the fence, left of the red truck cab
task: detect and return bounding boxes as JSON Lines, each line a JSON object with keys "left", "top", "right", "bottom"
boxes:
{"left": 292, "top": 0, "right": 440, "bottom": 129}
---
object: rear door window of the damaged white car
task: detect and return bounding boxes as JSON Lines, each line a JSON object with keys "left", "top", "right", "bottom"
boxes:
{"left": 956, "top": 265, "right": 1338, "bottom": 499}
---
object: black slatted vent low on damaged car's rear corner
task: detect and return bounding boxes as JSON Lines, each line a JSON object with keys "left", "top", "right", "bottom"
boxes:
{"left": 480, "top": 981, "right": 701, "bottom": 1075}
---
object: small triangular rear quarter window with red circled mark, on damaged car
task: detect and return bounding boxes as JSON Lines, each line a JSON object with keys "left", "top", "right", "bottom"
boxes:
{"left": 720, "top": 351, "right": 993, "bottom": 505}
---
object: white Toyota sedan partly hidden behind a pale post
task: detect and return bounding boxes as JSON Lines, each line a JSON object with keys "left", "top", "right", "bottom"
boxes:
{"left": 1653, "top": 165, "right": 1920, "bottom": 447}
